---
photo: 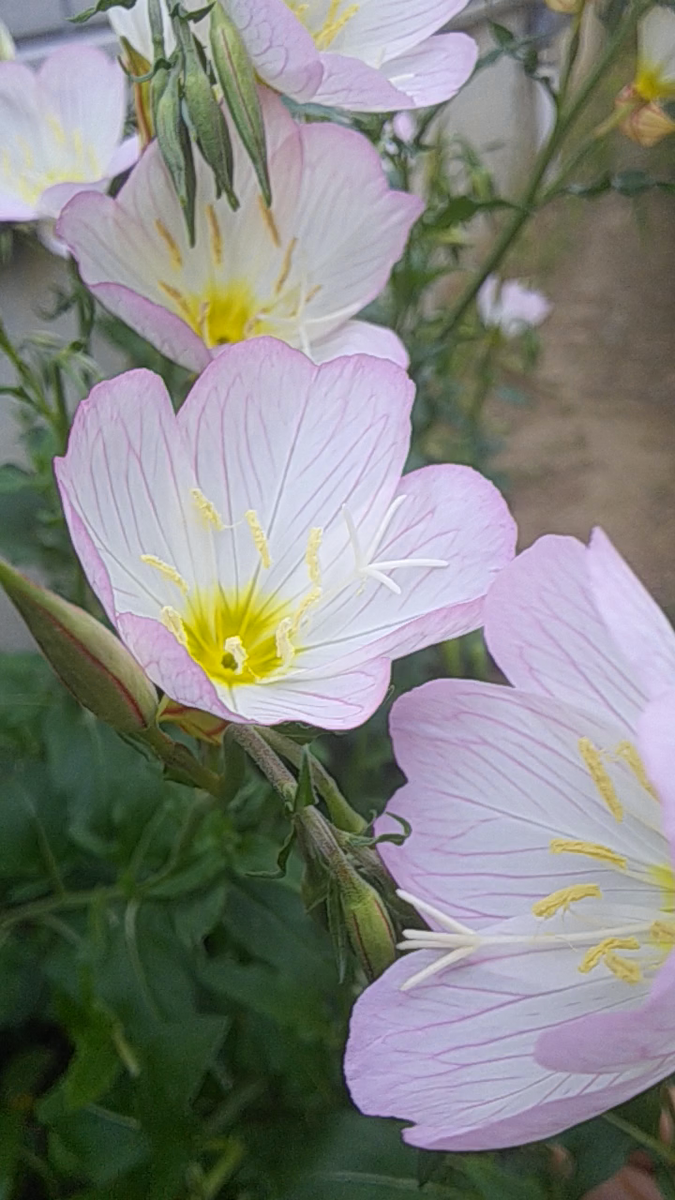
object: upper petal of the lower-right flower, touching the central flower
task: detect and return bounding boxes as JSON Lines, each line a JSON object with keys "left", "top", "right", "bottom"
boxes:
{"left": 485, "top": 536, "right": 645, "bottom": 727}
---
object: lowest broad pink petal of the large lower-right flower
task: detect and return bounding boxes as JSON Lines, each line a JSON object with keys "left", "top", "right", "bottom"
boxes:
{"left": 345, "top": 949, "right": 675, "bottom": 1151}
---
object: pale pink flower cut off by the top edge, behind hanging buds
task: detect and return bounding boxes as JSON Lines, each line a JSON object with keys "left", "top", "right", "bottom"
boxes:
{"left": 109, "top": 0, "right": 478, "bottom": 113}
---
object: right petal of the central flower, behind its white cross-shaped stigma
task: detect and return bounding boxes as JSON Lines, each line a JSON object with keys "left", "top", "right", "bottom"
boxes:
{"left": 296, "top": 464, "right": 515, "bottom": 673}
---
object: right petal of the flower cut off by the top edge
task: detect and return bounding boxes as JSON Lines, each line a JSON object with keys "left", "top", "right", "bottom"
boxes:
{"left": 382, "top": 34, "right": 478, "bottom": 108}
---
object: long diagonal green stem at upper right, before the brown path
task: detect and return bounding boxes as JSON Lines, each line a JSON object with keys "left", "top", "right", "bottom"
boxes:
{"left": 438, "top": 0, "right": 651, "bottom": 340}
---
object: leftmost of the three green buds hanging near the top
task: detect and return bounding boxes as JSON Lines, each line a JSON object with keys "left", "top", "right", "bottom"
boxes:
{"left": 151, "top": 65, "right": 197, "bottom": 246}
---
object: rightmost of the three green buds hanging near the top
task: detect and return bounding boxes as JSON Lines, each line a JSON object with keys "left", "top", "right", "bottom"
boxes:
{"left": 210, "top": 4, "right": 271, "bottom": 208}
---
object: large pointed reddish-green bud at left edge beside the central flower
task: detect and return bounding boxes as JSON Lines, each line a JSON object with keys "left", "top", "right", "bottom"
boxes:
{"left": 0, "top": 558, "right": 157, "bottom": 733}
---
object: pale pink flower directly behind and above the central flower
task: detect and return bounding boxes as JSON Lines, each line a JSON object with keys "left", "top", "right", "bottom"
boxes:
{"left": 59, "top": 92, "right": 423, "bottom": 371}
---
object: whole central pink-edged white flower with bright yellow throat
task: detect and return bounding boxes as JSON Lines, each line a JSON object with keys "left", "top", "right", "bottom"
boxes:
{"left": 55, "top": 338, "right": 514, "bottom": 728}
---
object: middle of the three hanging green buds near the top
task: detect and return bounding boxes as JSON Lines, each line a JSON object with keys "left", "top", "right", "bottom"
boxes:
{"left": 174, "top": 18, "right": 239, "bottom": 209}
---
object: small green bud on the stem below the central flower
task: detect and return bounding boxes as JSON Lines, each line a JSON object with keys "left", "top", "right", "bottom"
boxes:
{"left": 294, "top": 805, "right": 396, "bottom": 980}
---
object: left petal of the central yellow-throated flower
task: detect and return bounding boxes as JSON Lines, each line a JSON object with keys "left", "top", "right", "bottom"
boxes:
{"left": 55, "top": 371, "right": 214, "bottom": 620}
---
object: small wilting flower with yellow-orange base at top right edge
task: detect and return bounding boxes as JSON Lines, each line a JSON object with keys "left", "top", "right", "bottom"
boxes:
{"left": 616, "top": 5, "right": 675, "bottom": 146}
